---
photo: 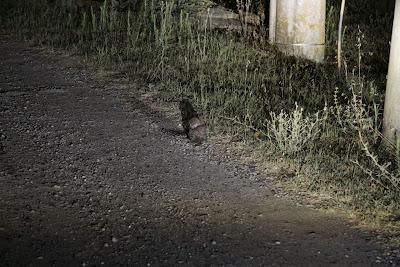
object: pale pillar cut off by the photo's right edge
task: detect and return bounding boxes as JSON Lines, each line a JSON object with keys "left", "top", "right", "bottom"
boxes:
{"left": 383, "top": 0, "right": 400, "bottom": 144}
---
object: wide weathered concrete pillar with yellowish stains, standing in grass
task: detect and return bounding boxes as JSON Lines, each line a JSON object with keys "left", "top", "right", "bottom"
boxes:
{"left": 270, "top": 0, "right": 326, "bottom": 62}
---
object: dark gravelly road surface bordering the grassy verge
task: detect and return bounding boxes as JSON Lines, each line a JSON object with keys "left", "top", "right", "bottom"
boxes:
{"left": 0, "top": 38, "right": 399, "bottom": 266}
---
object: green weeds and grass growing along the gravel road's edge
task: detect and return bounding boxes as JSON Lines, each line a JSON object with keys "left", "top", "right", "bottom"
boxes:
{"left": 0, "top": 0, "right": 400, "bottom": 230}
